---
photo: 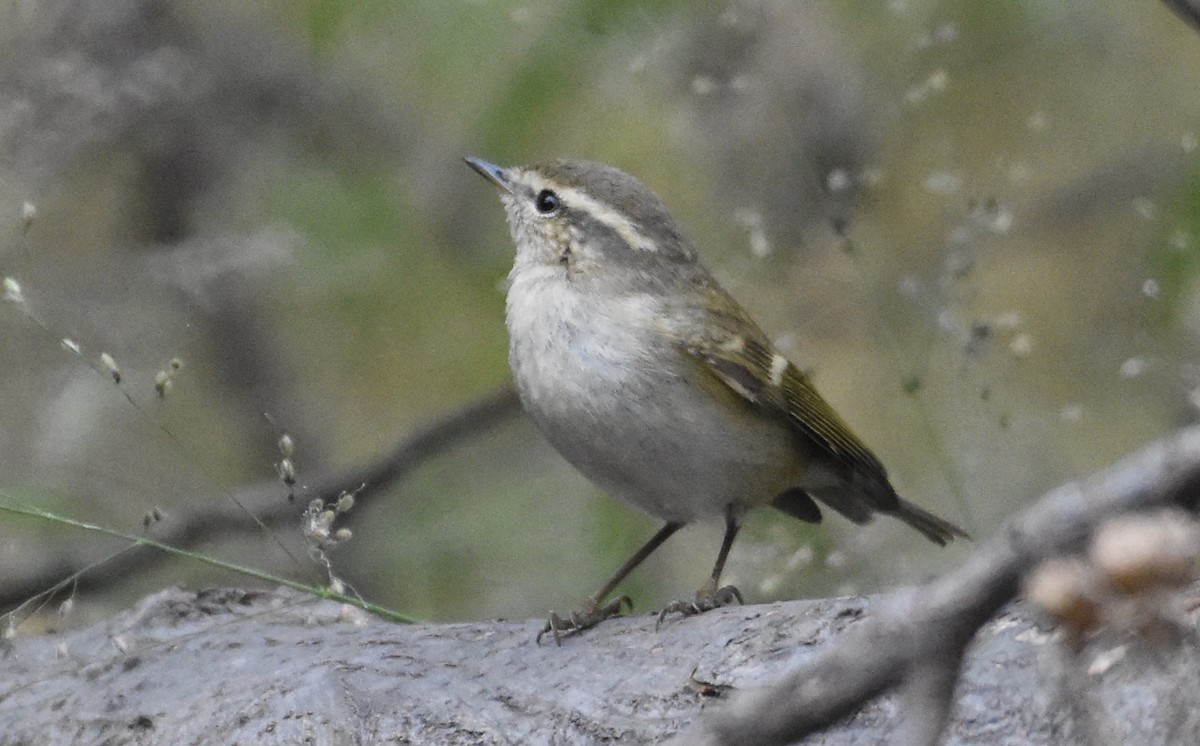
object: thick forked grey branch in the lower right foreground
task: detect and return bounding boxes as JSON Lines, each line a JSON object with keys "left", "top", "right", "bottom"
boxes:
{"left": 679, "top": 427, "right": 1200, "bottom": 745}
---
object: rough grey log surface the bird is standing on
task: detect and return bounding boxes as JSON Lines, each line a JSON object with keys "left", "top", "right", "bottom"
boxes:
{"left": 0, "top": 589, "right": 1200, "bottom": 745}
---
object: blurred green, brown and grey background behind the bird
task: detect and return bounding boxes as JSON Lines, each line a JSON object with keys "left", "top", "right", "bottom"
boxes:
{"left": 0, "top": 0, "right": 1200, "bottom": 633}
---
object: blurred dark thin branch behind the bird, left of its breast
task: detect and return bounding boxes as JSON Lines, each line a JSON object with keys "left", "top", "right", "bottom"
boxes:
{"left": 0, "top": 386, "right": 521, "bottom": 610}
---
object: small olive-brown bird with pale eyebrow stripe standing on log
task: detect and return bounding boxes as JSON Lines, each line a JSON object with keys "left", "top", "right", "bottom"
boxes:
{"left": 467, "top": 158, "right": 966, "bottom": 640}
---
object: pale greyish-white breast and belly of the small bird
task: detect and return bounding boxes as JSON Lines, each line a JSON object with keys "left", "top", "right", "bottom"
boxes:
{"left": 508, "top": 265, "right": 802, "bottom": 521}
